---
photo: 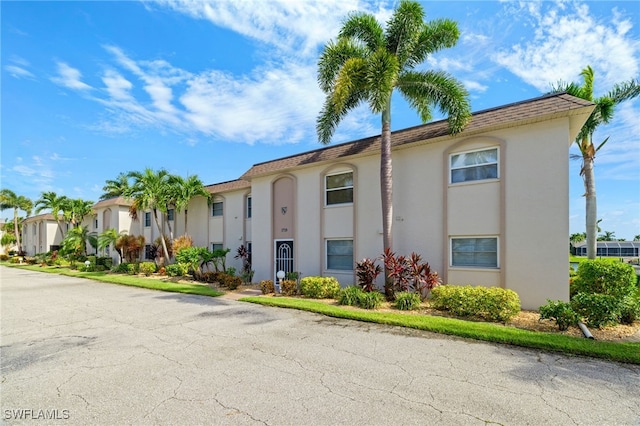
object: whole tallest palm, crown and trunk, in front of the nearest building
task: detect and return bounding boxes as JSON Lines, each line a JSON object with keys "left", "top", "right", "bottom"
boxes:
{"left": 316, "top": 0, "right": 471, "bottom": 294}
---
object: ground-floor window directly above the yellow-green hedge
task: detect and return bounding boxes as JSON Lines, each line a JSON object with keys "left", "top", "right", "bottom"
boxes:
{"left": 451, "top": 237, "right": 498, "bottom": 268}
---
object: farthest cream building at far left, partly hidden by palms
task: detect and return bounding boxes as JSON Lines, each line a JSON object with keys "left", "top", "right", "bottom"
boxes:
{"left": 21, "top": 213, "right": 69, "bottom": 256}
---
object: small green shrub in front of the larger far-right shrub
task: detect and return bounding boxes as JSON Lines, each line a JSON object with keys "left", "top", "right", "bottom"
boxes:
{"left": 571, "top": 293, "right": 622, "bottom": 328}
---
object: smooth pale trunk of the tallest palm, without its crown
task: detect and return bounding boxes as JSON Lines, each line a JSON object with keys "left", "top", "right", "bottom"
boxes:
{"left": 380, "top": 105, "right": 393, "bottom": 298}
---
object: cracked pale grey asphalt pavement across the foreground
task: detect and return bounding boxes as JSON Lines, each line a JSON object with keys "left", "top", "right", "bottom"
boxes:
{"left": 0, "top": 267, "right": 640, "bottom": 425}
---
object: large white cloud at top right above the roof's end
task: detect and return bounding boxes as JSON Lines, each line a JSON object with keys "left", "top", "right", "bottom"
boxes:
{"left": 493, "top": 2, "right": 640, "bottom": 92}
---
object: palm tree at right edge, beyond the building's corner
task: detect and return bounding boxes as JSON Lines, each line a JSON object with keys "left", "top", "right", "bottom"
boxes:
{"left": 552, "top": 66, "right": 640, "bottom": 259}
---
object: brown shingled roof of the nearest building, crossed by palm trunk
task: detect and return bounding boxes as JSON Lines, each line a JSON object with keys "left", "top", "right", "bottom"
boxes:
{"left": 240, "top": 93, "right": 593, "bottom": 180}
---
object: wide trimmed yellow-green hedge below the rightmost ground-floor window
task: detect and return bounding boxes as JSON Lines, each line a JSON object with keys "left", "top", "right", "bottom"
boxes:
{"left": 431, "top": 285, "right": 520, "bottom": 322}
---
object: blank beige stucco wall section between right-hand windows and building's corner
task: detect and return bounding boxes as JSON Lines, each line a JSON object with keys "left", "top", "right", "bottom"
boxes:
{"left": 504, "top": 118, "right": 571, "bottom": 309}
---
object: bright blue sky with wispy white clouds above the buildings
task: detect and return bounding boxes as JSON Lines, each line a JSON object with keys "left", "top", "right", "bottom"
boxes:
{"left": 0, "top": 0, "right": 640, "bottom": 239}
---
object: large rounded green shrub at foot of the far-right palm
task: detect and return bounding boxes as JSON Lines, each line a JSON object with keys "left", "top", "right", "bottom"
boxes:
{"left": 572, "top": 259, "right": 637, "bottom": 299}
